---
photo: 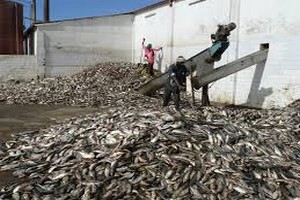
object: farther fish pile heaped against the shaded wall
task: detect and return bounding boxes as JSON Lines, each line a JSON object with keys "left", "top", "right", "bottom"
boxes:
{"left": 0, "top": 63, "right": 149, "bottom": 106}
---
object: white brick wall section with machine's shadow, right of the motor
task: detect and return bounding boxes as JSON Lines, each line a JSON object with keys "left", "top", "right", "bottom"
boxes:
{"left": 211, "top": 0, "right": 300, "bottom": 108}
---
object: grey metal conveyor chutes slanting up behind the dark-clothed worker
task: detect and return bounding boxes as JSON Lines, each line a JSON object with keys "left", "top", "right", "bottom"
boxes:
{"left": 138, "top": 43, "right": 269, "bottom": 95}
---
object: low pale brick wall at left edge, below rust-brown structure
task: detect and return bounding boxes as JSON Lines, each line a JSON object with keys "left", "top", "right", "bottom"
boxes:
{"left": 0, "top": 55, "right": 37, "bottom": 81}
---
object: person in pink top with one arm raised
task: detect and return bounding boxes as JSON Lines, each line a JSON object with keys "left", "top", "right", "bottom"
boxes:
{"left": 142, "top": 38, "right": 162, "bottom": 77}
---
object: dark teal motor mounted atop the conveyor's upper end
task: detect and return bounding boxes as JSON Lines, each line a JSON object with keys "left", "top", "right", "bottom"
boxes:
{"left": 206, "top": 22, "right": 236, "bottom": 63}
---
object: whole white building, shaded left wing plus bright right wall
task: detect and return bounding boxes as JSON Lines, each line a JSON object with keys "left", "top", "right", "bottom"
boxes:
{"left": 8, "top": 0, "right": 300, "bottom": 108}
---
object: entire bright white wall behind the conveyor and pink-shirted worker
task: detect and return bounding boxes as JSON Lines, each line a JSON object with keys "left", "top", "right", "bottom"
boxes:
{"left": 133, "top": 0, "right": 300, "bottom": 108}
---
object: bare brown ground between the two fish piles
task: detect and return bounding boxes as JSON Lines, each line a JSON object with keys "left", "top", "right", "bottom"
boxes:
{"left": 0, "top": 104, "right": 97, "bottom": 187}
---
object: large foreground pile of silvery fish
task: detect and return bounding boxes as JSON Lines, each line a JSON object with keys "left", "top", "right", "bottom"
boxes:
{"left": 0, "top": 104, "right": 300, "bottom": 200}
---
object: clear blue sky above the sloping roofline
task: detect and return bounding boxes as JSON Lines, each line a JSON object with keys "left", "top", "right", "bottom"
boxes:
{"left": 21, "top": 0, "right": 161, "bottom": 26}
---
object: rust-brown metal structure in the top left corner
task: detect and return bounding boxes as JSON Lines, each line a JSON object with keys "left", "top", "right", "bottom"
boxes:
{"left": 0, "top": 0, "right": 23, "bottom": 54}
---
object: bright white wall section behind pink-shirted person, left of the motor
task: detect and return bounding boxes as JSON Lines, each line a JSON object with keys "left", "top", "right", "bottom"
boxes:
{"left": 134, "top": 0, "right": 229, "bottom": 71}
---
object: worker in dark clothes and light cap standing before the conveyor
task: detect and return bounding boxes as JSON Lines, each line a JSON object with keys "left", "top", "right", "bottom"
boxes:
{"left": 163, "top": 56, "right": 189, "bottom": 111}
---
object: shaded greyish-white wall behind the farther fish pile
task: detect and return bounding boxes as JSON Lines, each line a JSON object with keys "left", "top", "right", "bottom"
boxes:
{"left": 36, "top": 15, "right": 132, "bottom": 76}
